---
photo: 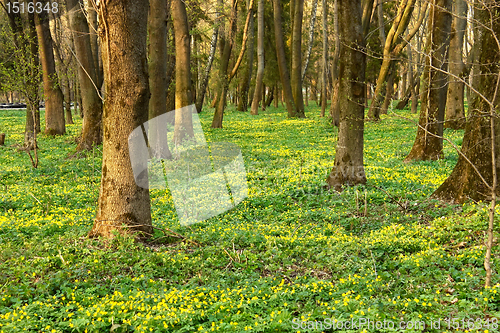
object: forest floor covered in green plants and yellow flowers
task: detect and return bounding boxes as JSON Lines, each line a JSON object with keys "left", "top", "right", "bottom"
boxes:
{"left": 0, "top": 105, "right": 500, "bottom": 332}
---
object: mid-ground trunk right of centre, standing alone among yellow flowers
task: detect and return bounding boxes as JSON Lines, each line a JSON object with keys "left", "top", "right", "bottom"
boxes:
{"left": 326, "top": 0, "right": 366, "bottom": 191}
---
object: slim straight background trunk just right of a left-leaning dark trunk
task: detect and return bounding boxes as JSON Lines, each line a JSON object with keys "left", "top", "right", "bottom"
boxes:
{"left": 290, "top": 0, "right": 305, "bottom": 118}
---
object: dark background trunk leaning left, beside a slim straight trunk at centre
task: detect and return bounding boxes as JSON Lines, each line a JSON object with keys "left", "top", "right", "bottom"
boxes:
{"left": 273, "top": 0, "right": 299, "bottom": 118}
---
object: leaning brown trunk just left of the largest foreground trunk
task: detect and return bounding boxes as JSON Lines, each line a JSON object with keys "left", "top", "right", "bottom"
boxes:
{"left": 67, "top": 0, "right": 102, "bottom": 151}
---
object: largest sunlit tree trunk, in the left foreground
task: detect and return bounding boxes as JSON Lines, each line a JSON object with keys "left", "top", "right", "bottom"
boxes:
{"left": 89, "top": 0, "right": 153, "bottom": 238}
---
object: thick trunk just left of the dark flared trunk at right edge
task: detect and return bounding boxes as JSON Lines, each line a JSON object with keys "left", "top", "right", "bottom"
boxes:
{"left": 405, "top": 0, "right": 452, "bottom": 162}
